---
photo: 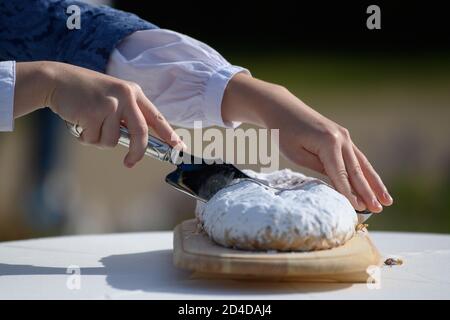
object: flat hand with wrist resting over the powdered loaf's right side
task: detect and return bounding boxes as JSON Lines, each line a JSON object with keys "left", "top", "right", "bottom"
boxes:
{"left": 222, "top": 74, "right": 393, "bottom": 212}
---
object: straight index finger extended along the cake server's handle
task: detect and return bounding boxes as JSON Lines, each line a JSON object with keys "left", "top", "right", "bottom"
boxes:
{"left": 137, "top": 91, "right": 186, "bottom": 148}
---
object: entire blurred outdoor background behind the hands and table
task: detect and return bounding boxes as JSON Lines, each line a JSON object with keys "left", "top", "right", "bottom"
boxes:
{"left": 0, "top": 0, "right": 450, "bottom": 240}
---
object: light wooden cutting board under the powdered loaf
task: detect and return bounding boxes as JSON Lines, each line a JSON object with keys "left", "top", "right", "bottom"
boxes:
{"left": 173, "top": 219, "right": 381, "bottom": 282}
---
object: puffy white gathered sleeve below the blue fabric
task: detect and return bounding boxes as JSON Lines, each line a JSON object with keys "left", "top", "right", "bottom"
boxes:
{"left": 107, "top": 29, "right": 250, "bottom": 127}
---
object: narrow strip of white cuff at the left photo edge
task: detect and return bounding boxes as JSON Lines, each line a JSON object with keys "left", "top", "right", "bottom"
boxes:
{"left": 0, "top": 61, "right": 16, "bottom": 131}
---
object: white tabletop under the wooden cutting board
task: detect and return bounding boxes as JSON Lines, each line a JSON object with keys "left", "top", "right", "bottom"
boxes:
{"left": 0, "top": 232, "right": 450, "bottom": 299}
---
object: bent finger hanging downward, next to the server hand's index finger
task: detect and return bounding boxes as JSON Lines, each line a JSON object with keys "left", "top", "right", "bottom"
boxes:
{"left": 123, "top": 101, "right": 148, "bottom": 168}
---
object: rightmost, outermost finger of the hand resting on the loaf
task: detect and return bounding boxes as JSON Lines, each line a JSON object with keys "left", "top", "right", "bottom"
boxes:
{"left": 353, "top": 145, "right": 394, "bottom": 206}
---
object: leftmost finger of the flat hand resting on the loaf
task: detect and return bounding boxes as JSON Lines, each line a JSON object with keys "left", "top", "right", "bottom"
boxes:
{"left": 320, "top": 146, "right": 365, "bottom": 211}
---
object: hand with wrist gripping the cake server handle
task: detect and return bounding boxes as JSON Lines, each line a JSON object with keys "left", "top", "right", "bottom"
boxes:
{"left": 14, "top": 62, "right": 181, "bottom": 168}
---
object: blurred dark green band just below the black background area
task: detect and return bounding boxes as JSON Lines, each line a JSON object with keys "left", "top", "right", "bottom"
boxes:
{"left": 224, "top": 49, "right": 450, "bottom": 99}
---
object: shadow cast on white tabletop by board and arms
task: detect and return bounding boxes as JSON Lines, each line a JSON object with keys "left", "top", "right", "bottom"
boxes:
{"left": 0, "top": 250, "right": 352, "bottom": 296}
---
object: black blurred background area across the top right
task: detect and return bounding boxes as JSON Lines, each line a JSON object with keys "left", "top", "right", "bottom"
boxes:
{"left": 117, "top": 0, "right": 450, "bottom": 53}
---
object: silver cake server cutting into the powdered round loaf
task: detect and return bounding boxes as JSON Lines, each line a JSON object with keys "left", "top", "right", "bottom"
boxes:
{"left": 66, "top": 122, "right": 372, "bottom": 223}
